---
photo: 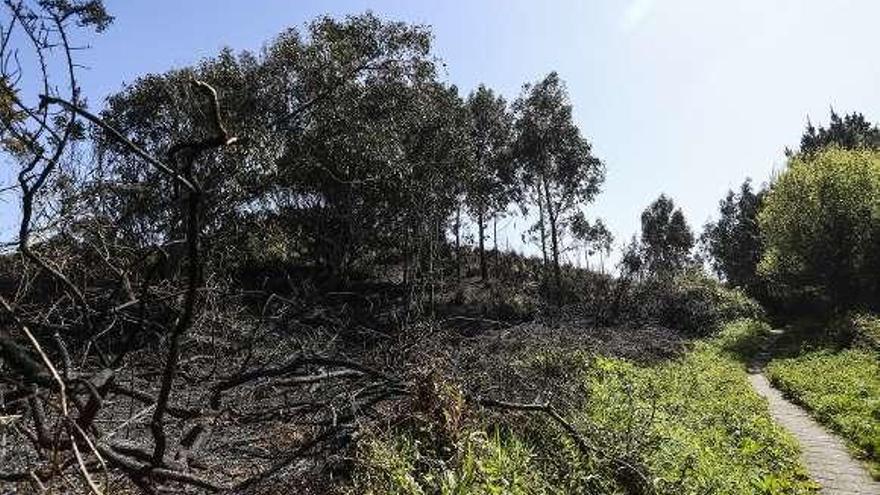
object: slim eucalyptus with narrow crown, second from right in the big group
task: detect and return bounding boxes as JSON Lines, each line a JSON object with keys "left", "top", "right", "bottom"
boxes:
{"left": 465, "top": 84, "right": 520, "bottom": 280}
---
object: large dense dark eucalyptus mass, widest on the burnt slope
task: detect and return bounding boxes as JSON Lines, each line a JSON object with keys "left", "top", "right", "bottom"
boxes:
{"left": 95, "top": 14, "right": 436, "bottom": 280}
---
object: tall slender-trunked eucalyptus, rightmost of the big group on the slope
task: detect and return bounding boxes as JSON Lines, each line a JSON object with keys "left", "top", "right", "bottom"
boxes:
{"left": 514, "top": 72, "right": 605, "bottom": 287}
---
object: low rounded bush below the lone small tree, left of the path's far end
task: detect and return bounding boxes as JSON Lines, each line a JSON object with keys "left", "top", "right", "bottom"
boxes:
{"left": 639, "top": 269, "right": 764, "bottom": 336}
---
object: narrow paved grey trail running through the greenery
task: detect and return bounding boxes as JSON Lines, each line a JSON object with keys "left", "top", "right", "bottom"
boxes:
{"left": 749, "top": 330, "right": 880, "bottom": 495}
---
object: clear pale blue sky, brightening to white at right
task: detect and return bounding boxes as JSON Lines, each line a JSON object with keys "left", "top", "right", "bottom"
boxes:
{"left": 0, "top": 0, "right": 880, "bottom": 262}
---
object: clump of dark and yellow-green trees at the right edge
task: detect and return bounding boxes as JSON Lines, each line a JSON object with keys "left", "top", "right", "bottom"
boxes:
{"left": 701, "top": 110, "right": 880, "bottom": 318}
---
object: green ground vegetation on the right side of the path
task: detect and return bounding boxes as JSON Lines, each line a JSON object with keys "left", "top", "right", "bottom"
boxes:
{"left": 767, "top": 349, "right": 880, "bottom": 479}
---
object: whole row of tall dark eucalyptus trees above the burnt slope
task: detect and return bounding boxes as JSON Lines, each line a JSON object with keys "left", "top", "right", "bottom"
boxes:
{"left": 71, "top": 14, "right": 610, "bottom": 300}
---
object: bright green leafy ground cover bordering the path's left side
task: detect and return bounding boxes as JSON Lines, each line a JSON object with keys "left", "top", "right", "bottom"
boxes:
{"left": 589, "top": 336, "right": 814, "bottom": 494}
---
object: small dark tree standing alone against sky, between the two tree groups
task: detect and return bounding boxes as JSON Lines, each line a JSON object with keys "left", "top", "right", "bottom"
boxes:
{"left": 642, "top": 194, "right": 694, "bottom": 275}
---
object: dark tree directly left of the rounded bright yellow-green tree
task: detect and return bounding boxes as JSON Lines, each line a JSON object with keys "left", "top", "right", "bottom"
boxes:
{"left": 700, "top": 179, "right": 766, "bottom": 291}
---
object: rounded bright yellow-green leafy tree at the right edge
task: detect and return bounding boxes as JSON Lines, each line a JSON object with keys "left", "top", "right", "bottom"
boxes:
{"left": 759, "top": 149, "right": 880, "bottom": 308}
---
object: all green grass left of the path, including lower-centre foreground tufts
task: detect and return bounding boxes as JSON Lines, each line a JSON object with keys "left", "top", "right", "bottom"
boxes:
{"left": 353, "top": 322, "right": 816, "bottom": 495}
